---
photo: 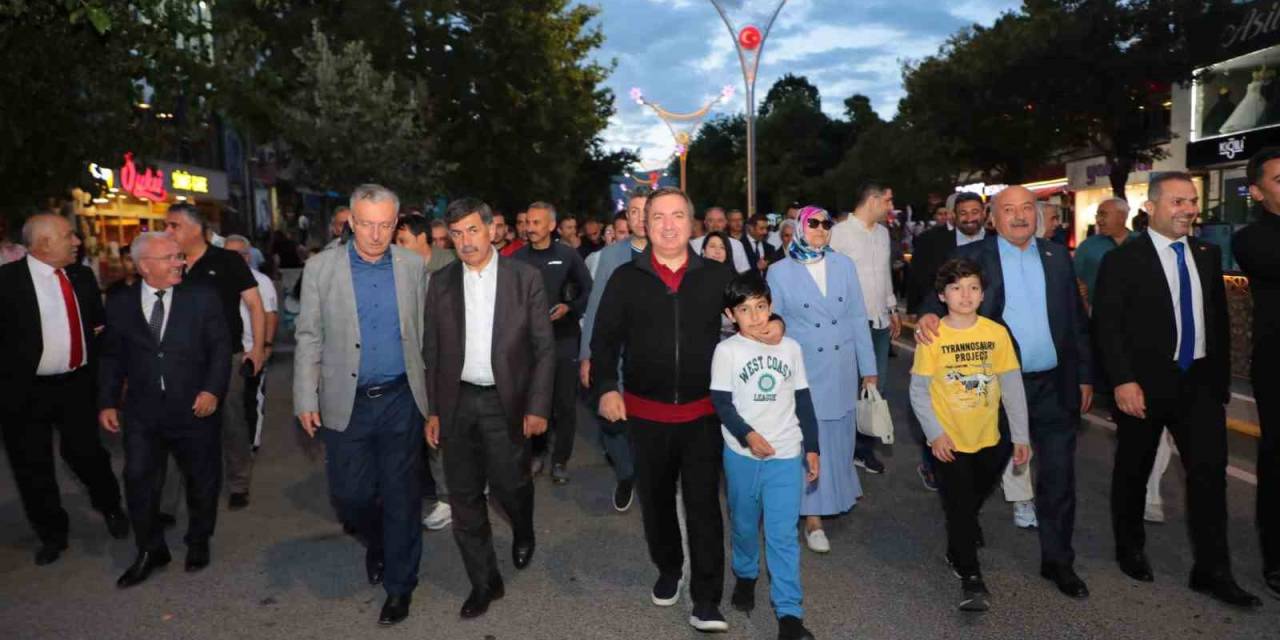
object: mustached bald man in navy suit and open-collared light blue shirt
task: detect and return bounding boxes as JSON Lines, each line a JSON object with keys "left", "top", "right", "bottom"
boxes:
{"left": 915, "top": 187, "right": 1093, "bottom": 598}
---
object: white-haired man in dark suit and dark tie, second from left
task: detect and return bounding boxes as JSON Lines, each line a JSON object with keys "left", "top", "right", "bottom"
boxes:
{"left": 97, "top": 232, "right": 232, "bottom": 589}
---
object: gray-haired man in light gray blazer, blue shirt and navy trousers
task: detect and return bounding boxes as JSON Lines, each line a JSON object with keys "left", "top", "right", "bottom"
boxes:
{"left": 293, "top": 184, "right": 428, "bottom": 625}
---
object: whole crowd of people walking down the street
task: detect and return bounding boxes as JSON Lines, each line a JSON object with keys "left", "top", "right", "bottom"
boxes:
{"left": 0, "top": 148, "right": 1280, "bottom": 639}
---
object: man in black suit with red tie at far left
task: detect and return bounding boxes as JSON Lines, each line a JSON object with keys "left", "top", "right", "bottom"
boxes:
{"left": 0, "top": 214, "right": 129, "bottom": 564}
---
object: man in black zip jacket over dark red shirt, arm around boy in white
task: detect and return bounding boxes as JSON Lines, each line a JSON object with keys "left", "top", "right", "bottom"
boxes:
{"left": 591, "top": 188, "right": 733, "bottom": 631}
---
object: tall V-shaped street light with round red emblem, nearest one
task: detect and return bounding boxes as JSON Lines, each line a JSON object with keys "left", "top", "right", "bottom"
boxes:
{"left": 710, "top": 0, "right": 787, "bottom": 218}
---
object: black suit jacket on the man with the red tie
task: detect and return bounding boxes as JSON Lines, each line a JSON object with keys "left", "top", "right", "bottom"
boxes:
{"left": 0, "top": 257, "right": 102, "bottom": 421}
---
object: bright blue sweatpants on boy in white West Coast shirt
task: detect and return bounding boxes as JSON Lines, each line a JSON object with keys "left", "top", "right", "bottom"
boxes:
{"left": 724, "top": 447, "right": 805, "bottom": 618}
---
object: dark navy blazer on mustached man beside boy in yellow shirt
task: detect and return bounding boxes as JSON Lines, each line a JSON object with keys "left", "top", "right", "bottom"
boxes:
{"left": 920, "top": 238, "right": 1093, "bottom": 415}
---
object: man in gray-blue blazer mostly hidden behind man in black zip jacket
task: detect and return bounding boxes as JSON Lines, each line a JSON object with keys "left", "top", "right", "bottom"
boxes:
{"left": 579, "top": 189, "right": 649, "bottom": 512}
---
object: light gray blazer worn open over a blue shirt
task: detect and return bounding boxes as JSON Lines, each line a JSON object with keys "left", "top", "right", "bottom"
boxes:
{"left": 293, "top": 244, "right": 429, "bottom": 431}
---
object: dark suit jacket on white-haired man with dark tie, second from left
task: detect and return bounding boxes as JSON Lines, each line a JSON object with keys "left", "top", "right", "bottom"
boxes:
{"left": 97, "top": 280, "right": 239, "bottom": 420}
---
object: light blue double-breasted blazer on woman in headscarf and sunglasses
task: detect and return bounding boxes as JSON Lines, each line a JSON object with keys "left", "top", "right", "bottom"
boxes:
{"left": 768, "top": 252, "right": 876, "bottom": 420}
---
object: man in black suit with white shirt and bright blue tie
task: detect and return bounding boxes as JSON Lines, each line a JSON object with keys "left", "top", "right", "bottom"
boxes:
{"left": 1093, "top": 172, "right": 1262, "bottom": 608}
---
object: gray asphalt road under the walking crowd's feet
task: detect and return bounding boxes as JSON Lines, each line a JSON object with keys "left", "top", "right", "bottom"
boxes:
{"left": 0, "top": 352, "right": 1280, "bottom": 640}
